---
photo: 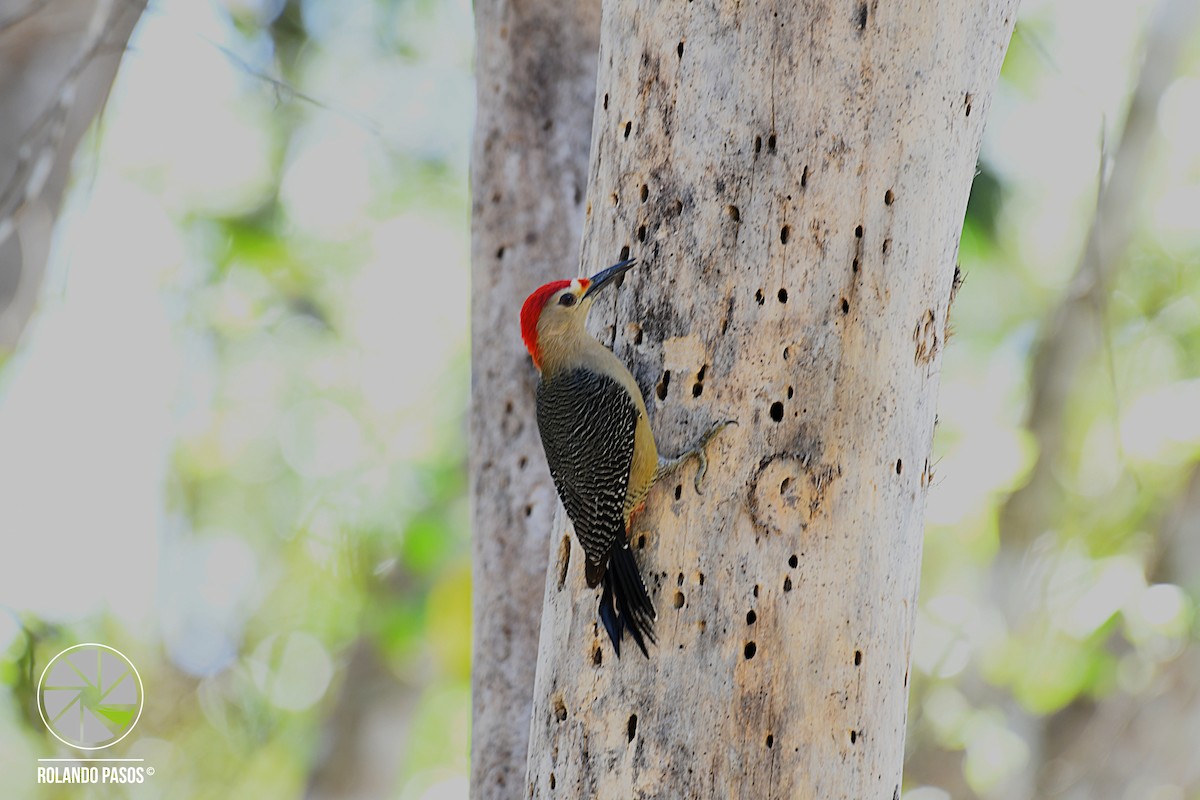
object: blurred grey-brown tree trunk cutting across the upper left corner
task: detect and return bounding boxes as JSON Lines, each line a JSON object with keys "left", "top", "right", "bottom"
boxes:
{"left": 0, "top": 0, "right": 145, "bottom": 355}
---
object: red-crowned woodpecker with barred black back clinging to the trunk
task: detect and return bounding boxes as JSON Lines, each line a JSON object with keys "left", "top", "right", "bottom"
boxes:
{"left": 521, "top": 259, "right": 732, "bottom": 658}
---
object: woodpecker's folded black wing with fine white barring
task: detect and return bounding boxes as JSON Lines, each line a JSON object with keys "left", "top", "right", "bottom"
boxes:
{"left": 538, "top": 369, "right": 637, "bottom": 587}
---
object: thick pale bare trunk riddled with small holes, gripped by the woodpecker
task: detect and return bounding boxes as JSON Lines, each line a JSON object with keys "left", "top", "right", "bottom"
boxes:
{"left": 527, "top": 0, "right": 1016, "bottom": 800}
